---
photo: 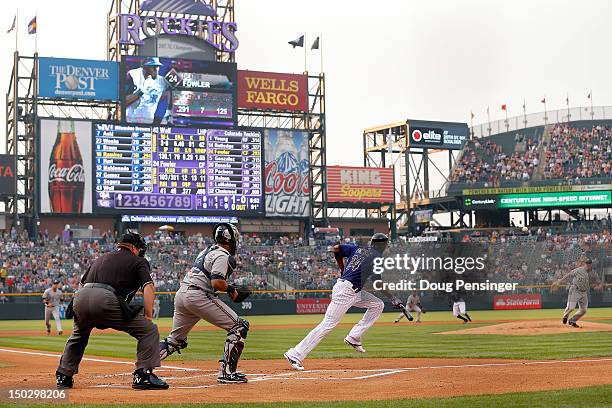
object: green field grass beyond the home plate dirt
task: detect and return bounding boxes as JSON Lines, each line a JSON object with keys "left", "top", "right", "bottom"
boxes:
{"left": 0, "top": 308, "right": 612, "bottom": 361}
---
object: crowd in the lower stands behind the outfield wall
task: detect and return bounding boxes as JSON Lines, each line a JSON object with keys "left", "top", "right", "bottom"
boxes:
{"left": 0, "top": 216, "right": 612, "bottom": 301}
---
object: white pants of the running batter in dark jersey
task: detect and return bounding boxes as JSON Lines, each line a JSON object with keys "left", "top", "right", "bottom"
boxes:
{"left": 287, "top": 280, "right": 385, "bottom": 361}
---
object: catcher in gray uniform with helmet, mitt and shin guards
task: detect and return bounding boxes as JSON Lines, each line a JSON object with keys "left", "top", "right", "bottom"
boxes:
{"left": 159, "top": 223, "right": 251, "bottom": 383}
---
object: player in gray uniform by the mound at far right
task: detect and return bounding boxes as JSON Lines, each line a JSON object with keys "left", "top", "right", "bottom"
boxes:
{"left": 552, "top": 259, "right": 604, "bottom": 327}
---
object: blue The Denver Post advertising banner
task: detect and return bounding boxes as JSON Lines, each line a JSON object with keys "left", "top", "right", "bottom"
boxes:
{"left": 38, "top": 57, "right": 119, "bottom": 101}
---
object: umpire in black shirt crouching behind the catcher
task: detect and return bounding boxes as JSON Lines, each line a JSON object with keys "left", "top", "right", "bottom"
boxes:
{"left": 55, "top": 232, "right": 168, "bottom": 390}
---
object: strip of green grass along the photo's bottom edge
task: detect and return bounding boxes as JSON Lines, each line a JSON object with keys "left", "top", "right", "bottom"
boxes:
{"left": 0, "top": 385, "right": 612, "bottom": 408}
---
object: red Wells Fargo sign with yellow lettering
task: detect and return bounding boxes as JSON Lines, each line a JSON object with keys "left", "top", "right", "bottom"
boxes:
{"left": 238, "top": 71, "right": 308, "bottom": 112}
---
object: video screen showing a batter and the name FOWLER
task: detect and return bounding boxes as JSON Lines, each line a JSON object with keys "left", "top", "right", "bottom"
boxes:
{"left": 121, "top": 56, "right": 237, "bottom": 126}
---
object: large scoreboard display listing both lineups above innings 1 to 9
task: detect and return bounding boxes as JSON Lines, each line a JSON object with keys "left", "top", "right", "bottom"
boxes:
{"left": 93, "top": 123, "right": 265, "bottom": 216}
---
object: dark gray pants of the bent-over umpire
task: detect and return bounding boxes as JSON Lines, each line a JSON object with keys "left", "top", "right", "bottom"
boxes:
{"left": 57, "top": 288, "right": 160, "bottom": 376}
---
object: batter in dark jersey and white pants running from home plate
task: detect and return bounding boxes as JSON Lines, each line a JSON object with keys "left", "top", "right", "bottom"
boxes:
{"left": 284, "top": 233, "right": 403, "bottom": 370}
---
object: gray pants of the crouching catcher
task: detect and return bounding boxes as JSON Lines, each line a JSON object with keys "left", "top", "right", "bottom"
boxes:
{"left": 168, "top": 286, "right": 238, "bottom": 343}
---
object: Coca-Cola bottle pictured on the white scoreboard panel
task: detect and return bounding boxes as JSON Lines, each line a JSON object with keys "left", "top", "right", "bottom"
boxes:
{"left": 49, "top": 120, "right": 85, "bottom": 214}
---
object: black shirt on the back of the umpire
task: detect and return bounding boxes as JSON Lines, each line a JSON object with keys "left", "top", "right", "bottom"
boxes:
{"left": 81, "top": 248, "right": 153, "bottom": 302}
